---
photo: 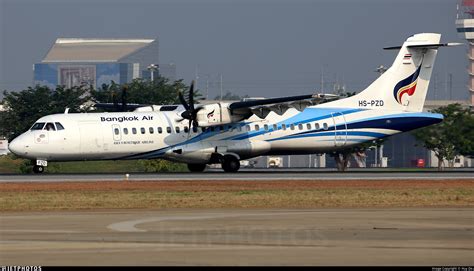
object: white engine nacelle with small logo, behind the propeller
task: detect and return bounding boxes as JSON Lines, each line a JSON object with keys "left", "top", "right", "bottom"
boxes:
{"left": 197, "top": 103, "right": 248, "bottom": 127}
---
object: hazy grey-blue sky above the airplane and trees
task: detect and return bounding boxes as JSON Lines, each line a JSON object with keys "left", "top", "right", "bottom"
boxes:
{"left": 0, "top": 0, "right": 468, "bottom": 99}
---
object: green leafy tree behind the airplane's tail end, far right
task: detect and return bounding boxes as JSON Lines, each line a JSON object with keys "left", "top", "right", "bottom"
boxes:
{"left": 413, "top": 104, "right": 474, "bottom": 170}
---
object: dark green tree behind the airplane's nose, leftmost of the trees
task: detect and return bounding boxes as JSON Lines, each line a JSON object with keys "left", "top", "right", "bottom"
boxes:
{"left": 0, "top": 85, "right": 89, "bottom": 140}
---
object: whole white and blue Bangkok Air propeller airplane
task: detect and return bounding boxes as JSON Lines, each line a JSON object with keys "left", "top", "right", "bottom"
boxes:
{"left": 9, "top": 33, "right": 459, "bottom": 173}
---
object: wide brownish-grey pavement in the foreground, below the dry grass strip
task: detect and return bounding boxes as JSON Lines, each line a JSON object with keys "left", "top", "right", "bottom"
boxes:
{"left": 0, "top": 208, "right": 474, "bottom": 266}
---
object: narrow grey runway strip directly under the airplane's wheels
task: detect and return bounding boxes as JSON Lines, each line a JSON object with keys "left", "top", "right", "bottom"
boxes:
{"left": 0, "top": 168, "right": 474, "bottom": 182}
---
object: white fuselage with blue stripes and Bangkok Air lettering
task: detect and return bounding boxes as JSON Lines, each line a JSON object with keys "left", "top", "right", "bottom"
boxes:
{"left": 10, "top": 103, "right": 442, "bottom": 163}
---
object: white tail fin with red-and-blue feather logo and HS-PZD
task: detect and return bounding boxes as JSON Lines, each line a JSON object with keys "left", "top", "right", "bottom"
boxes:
{"left": 321, "top": 33, "right": 442, "bottom": 112}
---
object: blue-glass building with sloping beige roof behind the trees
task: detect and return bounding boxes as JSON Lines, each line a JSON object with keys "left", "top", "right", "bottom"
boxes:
{"left": 33, "top": 38, "right": 159, "bottom": 88}
